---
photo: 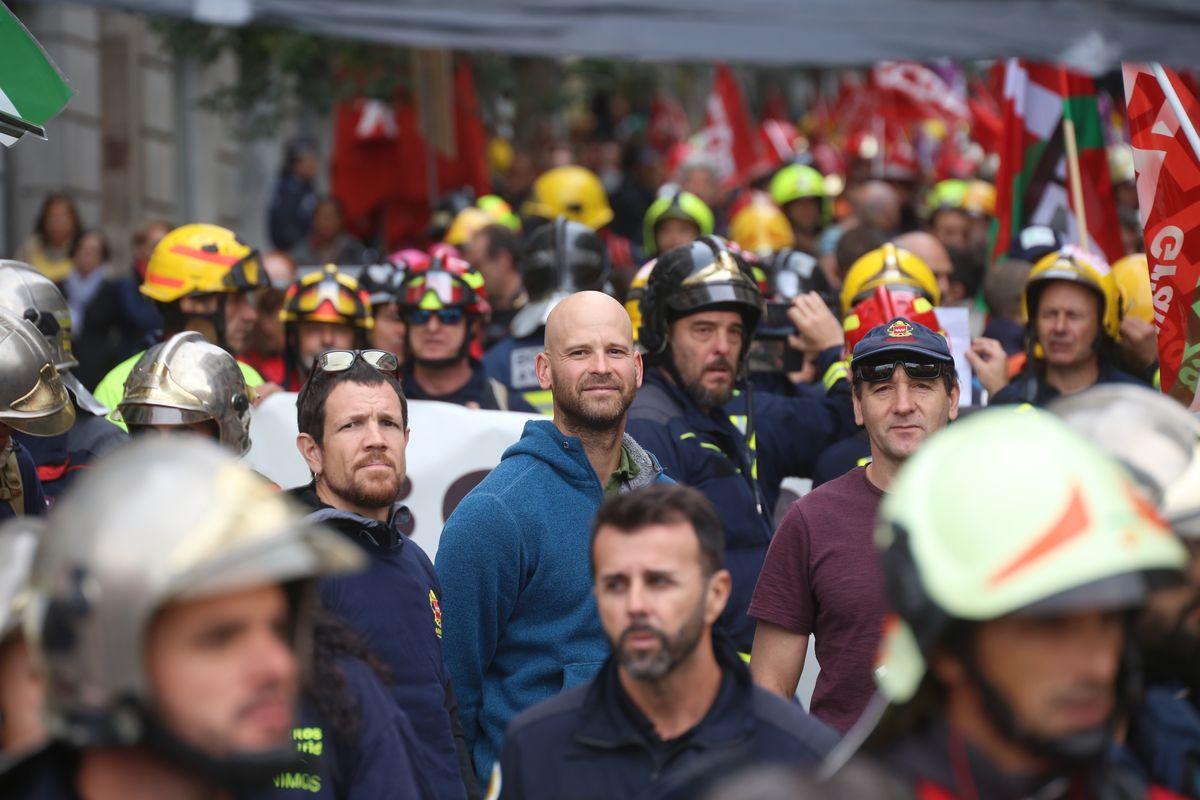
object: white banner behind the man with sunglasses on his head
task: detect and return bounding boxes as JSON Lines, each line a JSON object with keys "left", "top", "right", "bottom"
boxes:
{"left": 246, "top": 392, "right": 537, "bottom": 559}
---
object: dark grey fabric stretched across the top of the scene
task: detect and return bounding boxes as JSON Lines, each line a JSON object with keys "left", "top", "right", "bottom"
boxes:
{"left": 58, "top": 0, "right": 1200, "bottom": 72}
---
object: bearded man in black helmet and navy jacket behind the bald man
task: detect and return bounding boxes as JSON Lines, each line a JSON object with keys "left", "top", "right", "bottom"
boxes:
{"left": 629, "top": 236, "right": 854, "bottom": 652}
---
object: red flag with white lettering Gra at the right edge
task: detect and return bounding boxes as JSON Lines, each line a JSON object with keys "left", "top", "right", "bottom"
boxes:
{"left": 1123, "top": 64, "right": 1200, "bottom": 410}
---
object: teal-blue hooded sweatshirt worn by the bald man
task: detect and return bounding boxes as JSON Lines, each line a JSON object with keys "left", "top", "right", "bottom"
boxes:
{"left": 436, "top": 420, "right": 672, "bottom": 780}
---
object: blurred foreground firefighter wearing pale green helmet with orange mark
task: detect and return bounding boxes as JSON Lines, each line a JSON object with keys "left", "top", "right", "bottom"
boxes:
{"left": 859, "top": 409, "right": 1186, "bottom": 800}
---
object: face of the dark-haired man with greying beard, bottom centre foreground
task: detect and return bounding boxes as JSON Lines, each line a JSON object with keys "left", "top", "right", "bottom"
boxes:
{"left": 592, "top": 519, "right": 731, "bottom": 682}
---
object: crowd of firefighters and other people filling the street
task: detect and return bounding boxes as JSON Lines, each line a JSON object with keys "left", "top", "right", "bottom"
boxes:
{"left": 0, "top": 120, "right": 1200, "bottom": 800}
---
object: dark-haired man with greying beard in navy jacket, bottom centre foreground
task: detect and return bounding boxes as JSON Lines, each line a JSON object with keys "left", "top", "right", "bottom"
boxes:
{"left": 500, "top": 486, "right": 836, "bottom": 800}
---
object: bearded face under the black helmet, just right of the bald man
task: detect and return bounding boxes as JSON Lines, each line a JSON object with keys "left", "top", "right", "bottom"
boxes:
{"left": 668, "top": 311, "right": 745, "bottom": 410}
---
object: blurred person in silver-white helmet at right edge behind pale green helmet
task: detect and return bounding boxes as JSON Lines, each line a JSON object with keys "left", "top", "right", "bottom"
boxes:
{"left": 1050, "top": 385, "right": 1200, "bottom": 798}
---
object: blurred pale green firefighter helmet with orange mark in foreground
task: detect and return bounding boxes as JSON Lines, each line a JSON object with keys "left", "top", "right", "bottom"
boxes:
{"left": 876, "top": 408, "right": 1186, "bottom": 705}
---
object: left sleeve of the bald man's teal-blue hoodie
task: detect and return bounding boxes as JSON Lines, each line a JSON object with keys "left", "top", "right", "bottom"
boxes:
{"left": 436, "top": 492, "right": 523, "bottom": 762}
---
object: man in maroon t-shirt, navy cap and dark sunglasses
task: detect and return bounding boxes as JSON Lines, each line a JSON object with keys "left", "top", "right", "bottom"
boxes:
{"left": 750, "top": 318, "right": 959, "bottom": 733}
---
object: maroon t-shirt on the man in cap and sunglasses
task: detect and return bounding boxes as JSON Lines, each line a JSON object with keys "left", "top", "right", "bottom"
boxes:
{"left": 750, "top": 467, "right": 888, "bottom": 733}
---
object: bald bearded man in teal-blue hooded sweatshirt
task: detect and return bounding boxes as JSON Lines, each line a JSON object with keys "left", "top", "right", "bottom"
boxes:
{"left": 437, "top": 291, "right": 670, "bottom": 778}
